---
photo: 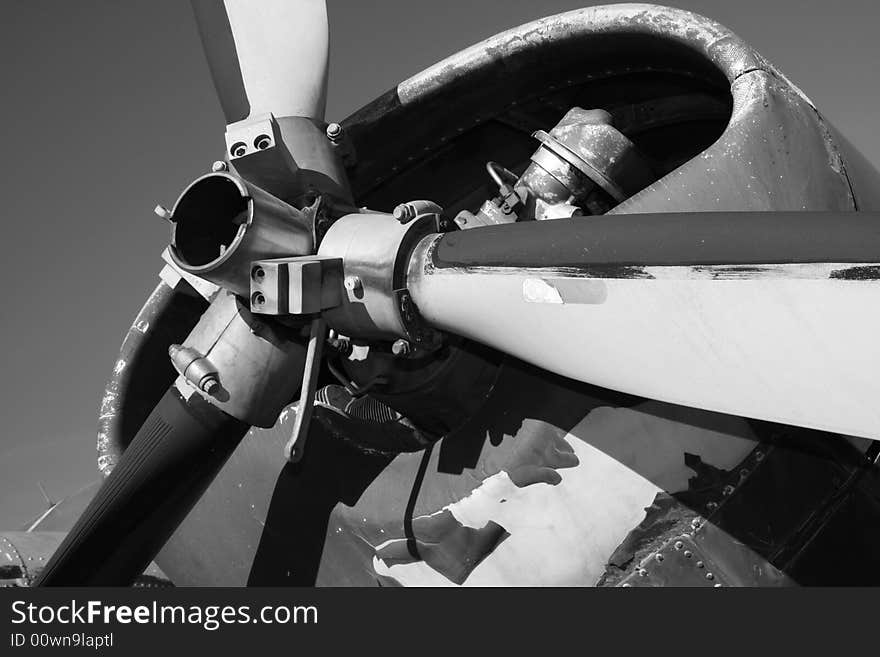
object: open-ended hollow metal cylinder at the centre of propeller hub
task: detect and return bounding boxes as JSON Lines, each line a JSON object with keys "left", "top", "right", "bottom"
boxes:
{"left": 169, "top": 172, "right": 314, "bottom": 297}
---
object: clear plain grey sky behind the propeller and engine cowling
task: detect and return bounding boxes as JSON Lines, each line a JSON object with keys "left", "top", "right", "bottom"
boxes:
{"left": 0, "top": 0, "right": 880, "bottom": 530}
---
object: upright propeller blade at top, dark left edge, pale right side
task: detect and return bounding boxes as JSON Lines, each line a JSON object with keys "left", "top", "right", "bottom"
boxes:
{"left": 192, "top": 0, "right": 329, "bottom": 124}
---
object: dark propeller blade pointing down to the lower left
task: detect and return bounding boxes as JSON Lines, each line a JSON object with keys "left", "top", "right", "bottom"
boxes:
{"left": 34, "top": 386, "right": 249, "bottom": 586}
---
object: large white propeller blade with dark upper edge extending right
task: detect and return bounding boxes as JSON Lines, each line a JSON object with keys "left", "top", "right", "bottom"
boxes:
{"left": 408, "top": 212, "right": 880, "bottom": 439}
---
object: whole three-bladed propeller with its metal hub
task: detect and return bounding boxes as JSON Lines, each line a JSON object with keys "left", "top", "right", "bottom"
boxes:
{"left": 36, "top": 0, "right": 880, "bottom": 586}
